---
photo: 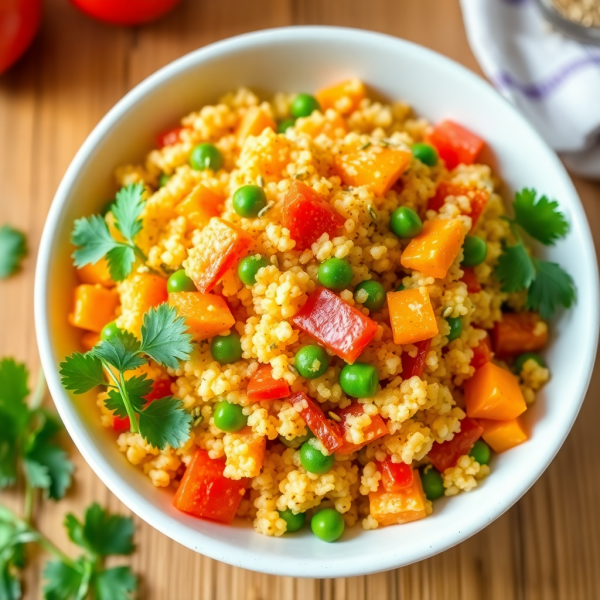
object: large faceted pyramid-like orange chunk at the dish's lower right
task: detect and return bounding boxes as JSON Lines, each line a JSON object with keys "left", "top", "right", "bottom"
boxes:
{"left": 465, "top": 362, "right": 527, "bottom": 421}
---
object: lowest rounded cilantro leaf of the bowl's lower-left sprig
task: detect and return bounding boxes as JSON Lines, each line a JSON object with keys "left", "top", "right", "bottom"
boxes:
{"left": 140, "top": 396, "right": 192, "bottom": 450}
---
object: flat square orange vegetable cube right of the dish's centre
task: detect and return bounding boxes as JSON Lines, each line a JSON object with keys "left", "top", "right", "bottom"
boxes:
{"left": 387, "top": 288, "right": 438, "bottom": 344}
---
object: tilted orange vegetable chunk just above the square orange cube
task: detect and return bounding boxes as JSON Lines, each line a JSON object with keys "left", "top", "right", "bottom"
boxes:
{"left": 400, "top": 219, "right": 465, "bottom": 279}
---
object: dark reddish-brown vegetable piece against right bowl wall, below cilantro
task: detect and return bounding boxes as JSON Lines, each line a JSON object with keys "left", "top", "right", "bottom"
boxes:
{"left": 493, "top": 312, "right": 548, "bottom": 358}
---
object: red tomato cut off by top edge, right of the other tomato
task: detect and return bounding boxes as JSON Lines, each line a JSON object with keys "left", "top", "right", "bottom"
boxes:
{"left": 71, "top": 0, "right": 180, "bottom": 25}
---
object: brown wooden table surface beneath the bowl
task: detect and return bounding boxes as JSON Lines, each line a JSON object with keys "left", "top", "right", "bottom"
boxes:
{"left": 0, "top": 0, "right": 600, "bottom": 600}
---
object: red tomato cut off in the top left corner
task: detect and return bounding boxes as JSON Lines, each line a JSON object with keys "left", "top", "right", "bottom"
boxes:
{"left": 0, "top": 0, "right": 42, "bottom": 73}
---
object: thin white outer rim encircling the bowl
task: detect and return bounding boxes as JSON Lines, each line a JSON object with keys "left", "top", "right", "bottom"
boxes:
{"left": 34, "top": 26, "right": 600, "bottom": 577}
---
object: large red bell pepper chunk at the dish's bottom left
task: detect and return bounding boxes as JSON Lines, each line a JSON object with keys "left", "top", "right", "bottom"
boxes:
{"left": 173, "top": 450, "right": 250, "bottom": 524}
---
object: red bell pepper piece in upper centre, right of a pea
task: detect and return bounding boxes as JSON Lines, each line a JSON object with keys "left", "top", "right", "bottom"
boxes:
{"left": 281, "top": 181, "right": 344, "bottom": 250}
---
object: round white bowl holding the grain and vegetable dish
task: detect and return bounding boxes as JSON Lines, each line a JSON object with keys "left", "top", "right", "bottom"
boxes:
{"left": 35, "top": 27, "right": 599, "bottom": 578}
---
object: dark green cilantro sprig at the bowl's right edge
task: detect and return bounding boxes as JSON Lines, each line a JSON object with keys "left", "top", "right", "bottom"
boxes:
{"left": 495, "top": 189, "right": 576, "bottom": 319}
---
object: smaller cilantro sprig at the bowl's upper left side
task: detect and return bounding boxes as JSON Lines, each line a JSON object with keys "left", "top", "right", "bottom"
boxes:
{"left": 71, "top": 183, "right": 147, "bottom": 281}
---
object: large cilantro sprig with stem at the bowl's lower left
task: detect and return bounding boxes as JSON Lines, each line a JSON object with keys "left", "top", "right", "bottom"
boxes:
{"left": 60, "top": 304, "right": 192, "bottom": 449}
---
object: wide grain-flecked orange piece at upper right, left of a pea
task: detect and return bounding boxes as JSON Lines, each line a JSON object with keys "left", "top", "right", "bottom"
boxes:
{"left": 334, "top": 146, "right": 412, "bottom": 198}
